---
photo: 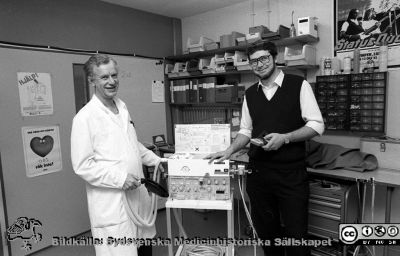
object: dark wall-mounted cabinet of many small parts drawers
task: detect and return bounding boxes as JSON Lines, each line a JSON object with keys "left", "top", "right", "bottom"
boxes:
{"left": 315, "top": 72, "right": 387, "bottom": 133}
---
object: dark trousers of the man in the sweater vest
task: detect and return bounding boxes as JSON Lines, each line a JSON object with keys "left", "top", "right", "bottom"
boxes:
{"left": 246, "top": 168, "right": 310, "bottom": 256}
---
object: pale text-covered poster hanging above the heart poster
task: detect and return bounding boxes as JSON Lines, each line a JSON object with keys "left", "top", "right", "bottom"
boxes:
{"left": 17, "top": 72, "right": 53, "bottom": 116}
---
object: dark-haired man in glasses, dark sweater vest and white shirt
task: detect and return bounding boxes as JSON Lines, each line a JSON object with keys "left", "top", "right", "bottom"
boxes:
{"left": 208, "top": 42, "right": 324, "bottom": 256}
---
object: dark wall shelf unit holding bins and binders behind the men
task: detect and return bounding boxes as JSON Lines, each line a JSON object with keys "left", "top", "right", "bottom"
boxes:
{"left": 164, "top": 35, "right": 319, "bottom": 144}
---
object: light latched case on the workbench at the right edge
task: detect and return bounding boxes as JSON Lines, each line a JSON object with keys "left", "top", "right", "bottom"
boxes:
{"left": 360, "top": 137, "right": 400, "bottom": 170}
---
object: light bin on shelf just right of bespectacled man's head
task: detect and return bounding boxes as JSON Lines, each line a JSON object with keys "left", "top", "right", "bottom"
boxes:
{"left": 284, "top": 44, "right": 316, "bottom": 66}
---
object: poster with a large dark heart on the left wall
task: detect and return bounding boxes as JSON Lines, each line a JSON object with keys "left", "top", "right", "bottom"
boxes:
{"left": 22, "top": 125, "right": 62, "bottom": 177}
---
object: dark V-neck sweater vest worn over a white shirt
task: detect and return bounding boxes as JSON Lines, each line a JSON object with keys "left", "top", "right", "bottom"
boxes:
{"left": 246, "top": 74, "right": 306, "bottom": 170}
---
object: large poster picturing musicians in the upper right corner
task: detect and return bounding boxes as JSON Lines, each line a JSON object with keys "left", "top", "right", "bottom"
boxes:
{"left": 335, "top": 0, "right": 400, "bottom": 71}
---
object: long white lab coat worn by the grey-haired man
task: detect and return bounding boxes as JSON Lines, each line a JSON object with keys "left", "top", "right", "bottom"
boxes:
{"left": 71, "top": 95, "right": 160, "bottom": 256}
